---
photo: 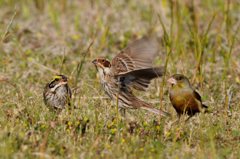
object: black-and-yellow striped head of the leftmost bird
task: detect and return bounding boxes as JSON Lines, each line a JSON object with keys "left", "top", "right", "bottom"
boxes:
{"left": 48, "top": 75, "right": 68, "bottom": 92}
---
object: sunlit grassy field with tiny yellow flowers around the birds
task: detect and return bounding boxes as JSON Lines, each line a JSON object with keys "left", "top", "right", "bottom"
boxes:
{"left": 0, "top": 0, "right": 240, "bottom": 159}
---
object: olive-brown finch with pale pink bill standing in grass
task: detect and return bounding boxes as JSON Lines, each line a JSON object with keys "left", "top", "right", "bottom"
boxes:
{"left": 168, "top": 74, "right": 207, "bottom": 117}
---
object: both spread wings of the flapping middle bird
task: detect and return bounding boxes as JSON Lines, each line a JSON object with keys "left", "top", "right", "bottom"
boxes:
{"left": 112, "top": 37, "right": 160, "bottom": 91}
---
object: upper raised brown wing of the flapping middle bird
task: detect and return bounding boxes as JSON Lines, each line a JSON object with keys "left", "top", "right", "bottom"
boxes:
{"left": 112, "top": 37, "right": 158, "bottom": 74}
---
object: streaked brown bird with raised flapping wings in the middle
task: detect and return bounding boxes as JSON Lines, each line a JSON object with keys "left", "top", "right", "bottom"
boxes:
{"left": 92, "top": 37, "right": 169, "bottom": 116}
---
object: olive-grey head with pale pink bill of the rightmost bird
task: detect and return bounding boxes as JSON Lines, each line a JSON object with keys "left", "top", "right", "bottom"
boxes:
{"left": 167, "top": 74, "right": 191, "bottom": 88}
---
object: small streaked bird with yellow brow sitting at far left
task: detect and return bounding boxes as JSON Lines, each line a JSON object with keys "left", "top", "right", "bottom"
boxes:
{"left": 43, "top": 75, "right": 72, "bottom": 111}
